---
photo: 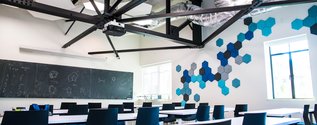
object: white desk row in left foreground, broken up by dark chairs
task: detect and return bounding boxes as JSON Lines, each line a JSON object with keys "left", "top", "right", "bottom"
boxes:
{"left": 0, "top": 113, "right": 167, "bottom": 124}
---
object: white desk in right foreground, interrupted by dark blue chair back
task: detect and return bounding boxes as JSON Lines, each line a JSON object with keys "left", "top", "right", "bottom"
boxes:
{"left": 184, "top": 117, "right": 301, "bottom": 125}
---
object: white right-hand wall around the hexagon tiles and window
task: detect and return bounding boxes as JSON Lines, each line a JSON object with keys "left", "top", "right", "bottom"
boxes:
{"left": 140, "top": 1, "right": 317, "bottom": 109}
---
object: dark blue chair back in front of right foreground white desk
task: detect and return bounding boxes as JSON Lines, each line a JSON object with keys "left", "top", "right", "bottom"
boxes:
{"left": 242, "top": 112, "right": 266, "bottom": 125}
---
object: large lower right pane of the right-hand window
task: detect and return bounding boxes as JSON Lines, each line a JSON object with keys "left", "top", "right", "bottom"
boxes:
{"left": 292, "top": 51, "right": 313, "bottom": 98}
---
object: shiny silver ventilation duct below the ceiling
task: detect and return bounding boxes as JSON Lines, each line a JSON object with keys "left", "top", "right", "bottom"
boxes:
{"left": 136, "top": 0, "right": 278, "bottom": 28}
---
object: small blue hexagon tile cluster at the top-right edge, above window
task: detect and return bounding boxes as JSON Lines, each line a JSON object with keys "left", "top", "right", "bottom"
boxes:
{"left": 291, "top": 5, "right": 317, "bottom": 35}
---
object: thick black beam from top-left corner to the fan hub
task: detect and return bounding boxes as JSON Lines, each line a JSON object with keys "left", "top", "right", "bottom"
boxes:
{"left": 1, "top": 0, "right": 100, "bottom": 24}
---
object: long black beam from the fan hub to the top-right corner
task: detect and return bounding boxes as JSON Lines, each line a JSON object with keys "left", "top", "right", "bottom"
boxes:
{"left": 118, "top": 0, "right": 317, "bottom": 23}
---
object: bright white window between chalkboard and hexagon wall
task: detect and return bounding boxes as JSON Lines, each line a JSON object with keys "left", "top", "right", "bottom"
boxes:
{"left": 142, "top": 63, "right": 172, "bottom": 99}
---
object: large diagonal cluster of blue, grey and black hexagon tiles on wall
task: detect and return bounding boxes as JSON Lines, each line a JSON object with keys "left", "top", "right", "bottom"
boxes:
{"left": 176, "top": 17, "right": 276, "bottom": 104}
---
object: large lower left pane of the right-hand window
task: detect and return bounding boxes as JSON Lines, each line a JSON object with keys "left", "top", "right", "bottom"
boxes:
{"left": 272, "top": 54, "right": 292, "bottom": 98}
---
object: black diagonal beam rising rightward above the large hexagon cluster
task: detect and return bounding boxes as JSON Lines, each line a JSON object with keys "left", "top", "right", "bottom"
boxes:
{"left": 202, "top": 0, "right": 262, "bottom": 46}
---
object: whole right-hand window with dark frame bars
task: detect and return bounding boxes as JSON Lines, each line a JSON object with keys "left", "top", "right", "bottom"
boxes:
{"left": 266, "top": 36, "right": 313, "bottom": 99}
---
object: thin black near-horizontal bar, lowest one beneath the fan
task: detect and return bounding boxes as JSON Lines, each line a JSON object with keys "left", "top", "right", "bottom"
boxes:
{"left": 88, "top": 46, "right": 195, "bottom": 55}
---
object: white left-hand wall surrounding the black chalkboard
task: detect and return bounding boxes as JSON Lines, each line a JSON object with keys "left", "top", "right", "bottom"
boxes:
{"left": 0, "top": 5, "right": 140, "bottom": 113}
